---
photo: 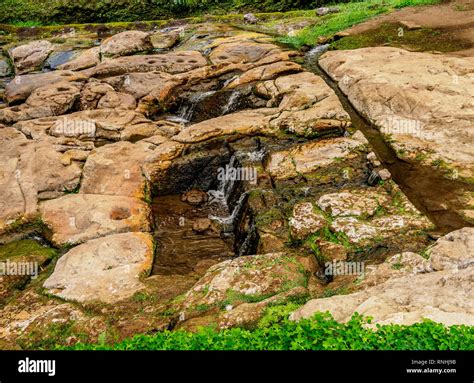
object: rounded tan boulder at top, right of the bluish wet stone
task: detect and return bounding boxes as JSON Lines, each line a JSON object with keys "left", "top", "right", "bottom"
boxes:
{"left": 100, "top": 31, "right": 153, "bottom": 57}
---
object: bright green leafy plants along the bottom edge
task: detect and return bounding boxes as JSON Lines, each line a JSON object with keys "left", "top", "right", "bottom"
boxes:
{"left": 61, "top": 312, "right": 474, "bottom": 350}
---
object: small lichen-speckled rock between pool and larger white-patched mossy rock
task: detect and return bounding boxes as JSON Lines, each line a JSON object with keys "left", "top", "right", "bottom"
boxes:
{"left": 290, "top": 202, "right": 326, "bottom": 239}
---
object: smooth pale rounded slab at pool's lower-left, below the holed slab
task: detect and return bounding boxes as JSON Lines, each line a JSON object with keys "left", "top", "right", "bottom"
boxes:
{"left": 43, "top": 233, "right": 153, "bottom": 304}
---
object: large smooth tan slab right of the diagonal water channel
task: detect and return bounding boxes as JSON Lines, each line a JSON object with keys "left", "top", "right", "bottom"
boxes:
{"left": 319, "top": 47, "right": 474, "bottom": 177}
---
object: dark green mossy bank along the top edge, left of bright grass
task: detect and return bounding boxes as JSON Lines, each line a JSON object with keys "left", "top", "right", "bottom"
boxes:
{"left": 0, "top": 0, "right": 344, "bottom": 26}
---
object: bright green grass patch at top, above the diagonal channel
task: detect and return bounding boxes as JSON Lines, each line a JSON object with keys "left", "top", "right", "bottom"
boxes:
{"left": 280, "top": 0, "right": 440, "bottom": 48}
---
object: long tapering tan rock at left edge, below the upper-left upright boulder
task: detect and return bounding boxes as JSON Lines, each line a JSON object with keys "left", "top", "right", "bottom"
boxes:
{"left": 5, "top": 70, "right": 87, "bottom": 103}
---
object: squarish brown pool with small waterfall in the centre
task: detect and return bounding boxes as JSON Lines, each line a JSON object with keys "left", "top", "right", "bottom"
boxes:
{"left": 151, "top": 143, "right": 257, "bottom": 276}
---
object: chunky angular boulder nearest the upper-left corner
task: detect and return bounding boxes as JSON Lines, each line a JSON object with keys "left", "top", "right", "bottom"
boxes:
{"left": 9, "top": 40, "right": 53, "bottom": 74}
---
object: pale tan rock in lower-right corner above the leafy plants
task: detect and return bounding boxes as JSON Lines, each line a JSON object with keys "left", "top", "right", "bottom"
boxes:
{"left": 291, "top": 228, "right": 474, "bottom": 326}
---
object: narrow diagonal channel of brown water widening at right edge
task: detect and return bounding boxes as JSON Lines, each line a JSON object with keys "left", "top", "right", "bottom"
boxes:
{"left": 304, "top": 47, "right": 474, "bottom": 236}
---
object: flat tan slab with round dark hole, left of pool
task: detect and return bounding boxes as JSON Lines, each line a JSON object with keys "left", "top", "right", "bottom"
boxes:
{"left": 40, "top": 194, "right": 150, "bottom": 246}
